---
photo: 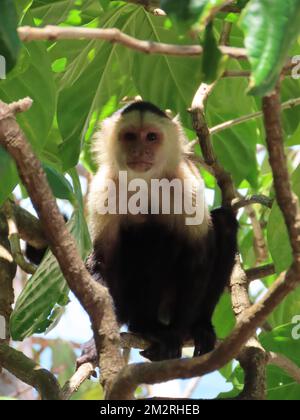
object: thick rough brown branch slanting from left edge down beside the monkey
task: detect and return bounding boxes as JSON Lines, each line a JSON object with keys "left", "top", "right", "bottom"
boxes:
{"left": 0, "top": 97, "right": 123, "bottom": 398}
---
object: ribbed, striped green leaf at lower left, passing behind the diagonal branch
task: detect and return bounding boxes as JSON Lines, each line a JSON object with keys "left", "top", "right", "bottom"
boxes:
{"left": 10, "top": 208, "right": 90, "bottom": 341}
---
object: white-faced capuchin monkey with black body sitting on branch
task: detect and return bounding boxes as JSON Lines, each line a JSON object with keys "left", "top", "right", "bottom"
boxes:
{"left": 81, "top": 101, "right": 238, "bottom": 362}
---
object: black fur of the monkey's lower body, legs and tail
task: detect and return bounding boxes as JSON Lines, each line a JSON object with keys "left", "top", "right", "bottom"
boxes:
{"left": 87, "top": 208, "right": 237, "bottom": 360}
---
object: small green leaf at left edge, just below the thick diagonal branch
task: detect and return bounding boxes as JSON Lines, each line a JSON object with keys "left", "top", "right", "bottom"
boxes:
{"left": 0, "top": 146, "right": 19, "bottom": 206}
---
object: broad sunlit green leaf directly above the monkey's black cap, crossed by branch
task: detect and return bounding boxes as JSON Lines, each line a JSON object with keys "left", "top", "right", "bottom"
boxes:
{"left": 130, "top": 9, "right": 201, "bottom": 127}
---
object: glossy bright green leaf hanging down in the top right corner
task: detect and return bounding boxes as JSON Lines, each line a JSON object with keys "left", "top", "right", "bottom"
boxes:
{"left": 241, "top": 0, "right": 300, "bottom": 96}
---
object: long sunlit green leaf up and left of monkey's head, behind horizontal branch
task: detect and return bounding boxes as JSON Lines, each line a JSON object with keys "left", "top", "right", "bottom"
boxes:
{"left": 58, "top": 6, "right": 138, "bottom": 169}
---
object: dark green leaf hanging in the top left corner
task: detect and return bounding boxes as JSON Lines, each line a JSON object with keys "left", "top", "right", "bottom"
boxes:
{"left": 0, "top": 0, "right": 21, "bottom": 72}
